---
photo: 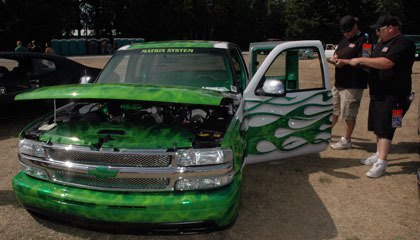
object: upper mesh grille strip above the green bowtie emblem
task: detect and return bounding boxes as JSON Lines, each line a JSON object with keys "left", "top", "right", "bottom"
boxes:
{"left": 45, "top": 147, "right": 172, "bottom": 167}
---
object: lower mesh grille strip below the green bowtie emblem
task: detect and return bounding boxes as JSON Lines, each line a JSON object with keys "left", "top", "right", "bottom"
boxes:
{"left": 52, "top": 170, "right": 169, "bottom": 190}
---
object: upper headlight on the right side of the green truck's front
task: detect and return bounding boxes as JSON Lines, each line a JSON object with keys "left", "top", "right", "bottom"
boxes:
{"left": 176, "top": 148, "right": 232, "bottom": 167}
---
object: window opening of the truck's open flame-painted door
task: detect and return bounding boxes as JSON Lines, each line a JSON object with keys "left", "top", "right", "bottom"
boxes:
{"left": 263, "top": 48, "right": 325, "bottom": 92}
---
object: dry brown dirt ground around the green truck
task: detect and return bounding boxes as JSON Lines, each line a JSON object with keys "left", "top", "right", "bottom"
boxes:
{"left": 0, "top": 54, "right": 420, "bottom": 240}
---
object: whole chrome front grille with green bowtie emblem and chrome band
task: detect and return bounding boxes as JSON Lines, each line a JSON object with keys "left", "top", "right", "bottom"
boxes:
{"left": 19, "top": 144, "right": 233, "bottom": 192}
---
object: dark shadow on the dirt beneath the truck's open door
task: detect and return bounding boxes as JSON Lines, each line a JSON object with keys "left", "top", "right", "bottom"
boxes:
{"left": 233, "top": 154, "right": 344, "bottom": 239}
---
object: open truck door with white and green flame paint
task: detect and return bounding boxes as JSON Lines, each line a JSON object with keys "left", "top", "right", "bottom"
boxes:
{"left": 242, "top": 41, "right": 332, "bottom": 164}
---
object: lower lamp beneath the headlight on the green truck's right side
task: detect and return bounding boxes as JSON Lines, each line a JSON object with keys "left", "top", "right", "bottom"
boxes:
{"left": 175, "top": 172, "right": 233, "bottom": 191}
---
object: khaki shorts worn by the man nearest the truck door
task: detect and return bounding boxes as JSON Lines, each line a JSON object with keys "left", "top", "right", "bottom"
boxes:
{"left": 332, "top": 87, "right": 364, "bottom": 120}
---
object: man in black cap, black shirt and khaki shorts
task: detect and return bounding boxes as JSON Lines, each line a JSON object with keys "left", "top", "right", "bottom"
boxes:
{"left": 329, "top": 15, "right": 369, "bottom": 150}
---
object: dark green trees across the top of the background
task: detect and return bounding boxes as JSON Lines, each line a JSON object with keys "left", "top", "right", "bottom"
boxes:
{"left": 0, "top": 0, "right": 420, "bottom": 50}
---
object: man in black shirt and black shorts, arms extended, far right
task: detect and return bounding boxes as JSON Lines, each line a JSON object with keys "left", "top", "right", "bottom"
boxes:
{"left": 338, "top": 15, "right": 416, "bottom": 178}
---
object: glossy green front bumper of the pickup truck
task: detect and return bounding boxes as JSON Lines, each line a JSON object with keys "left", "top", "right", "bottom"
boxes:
{"left": 13, "top": 172, "right": 242, "bottom": 231}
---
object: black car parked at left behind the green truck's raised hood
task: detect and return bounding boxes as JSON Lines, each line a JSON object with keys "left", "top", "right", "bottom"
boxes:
{"left": 0, "top": 52, "right": 101, "bottom": 118}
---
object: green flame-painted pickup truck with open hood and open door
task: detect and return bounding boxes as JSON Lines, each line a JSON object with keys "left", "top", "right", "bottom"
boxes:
{"left": 13, "top": 41, "right": 332, "bottom": 233}
